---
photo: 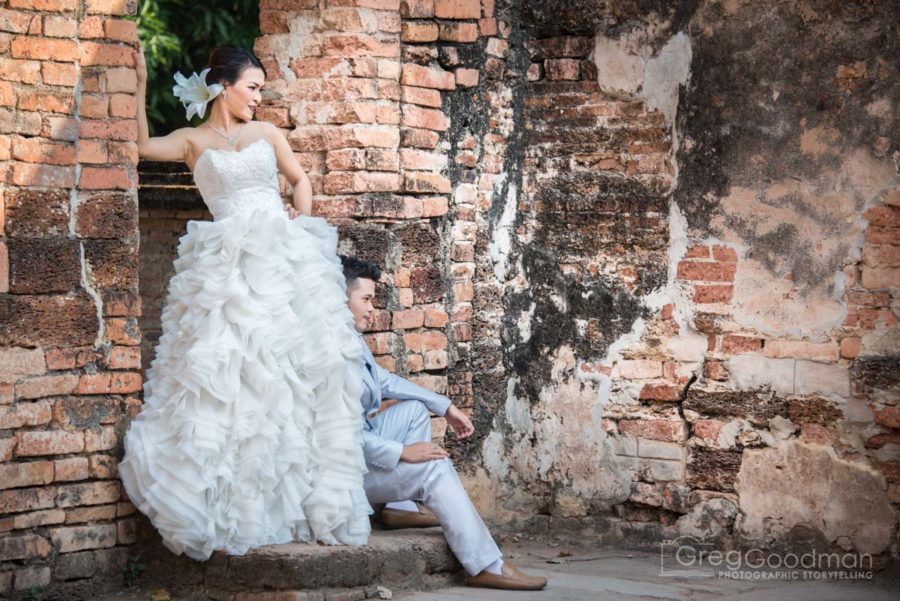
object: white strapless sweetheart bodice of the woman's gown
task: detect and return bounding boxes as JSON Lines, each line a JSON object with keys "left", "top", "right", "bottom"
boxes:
{"left": 194, "top": 138, "right": 283, "bottom": 221}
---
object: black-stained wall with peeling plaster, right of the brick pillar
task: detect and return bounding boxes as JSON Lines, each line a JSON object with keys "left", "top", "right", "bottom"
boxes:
{"left": 460, "top": 2, "right": 900, "bottom": 554}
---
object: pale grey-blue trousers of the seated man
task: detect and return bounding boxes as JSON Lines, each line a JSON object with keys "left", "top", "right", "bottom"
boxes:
{"left": 365, "top": 401, "right": 502, "bottom": 576}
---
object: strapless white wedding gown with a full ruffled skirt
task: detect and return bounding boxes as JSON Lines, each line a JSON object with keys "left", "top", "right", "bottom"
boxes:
{"left": 119, "top": 139, "right": 371, "bottom": 559}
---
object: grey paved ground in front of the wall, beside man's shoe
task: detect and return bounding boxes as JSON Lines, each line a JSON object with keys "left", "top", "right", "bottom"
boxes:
{"left": 394, "top": 545, "right": 900, "bottom": 601}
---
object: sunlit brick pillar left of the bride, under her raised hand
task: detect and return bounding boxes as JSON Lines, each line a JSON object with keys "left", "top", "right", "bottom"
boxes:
{"left": 0, "top": 0, "right": 141, "bottom": 595}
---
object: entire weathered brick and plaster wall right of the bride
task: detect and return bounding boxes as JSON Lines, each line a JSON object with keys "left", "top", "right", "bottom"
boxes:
{"left": 251, "top": 0, "right": 900, "bottom": 564}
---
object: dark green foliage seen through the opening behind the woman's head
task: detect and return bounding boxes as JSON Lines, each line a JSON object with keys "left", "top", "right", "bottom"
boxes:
{"left": 134, "top": 0, "right": 260, "bottom": 136}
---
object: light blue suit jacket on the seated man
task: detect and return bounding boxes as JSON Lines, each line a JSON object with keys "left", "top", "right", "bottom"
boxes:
{"left": 359, "top": 336, "right": 451, "bottom": 470}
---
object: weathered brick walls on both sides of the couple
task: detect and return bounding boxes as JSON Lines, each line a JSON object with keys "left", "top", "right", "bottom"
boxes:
{"left": 7, "top": 0, "right": 900, "bottom": 589}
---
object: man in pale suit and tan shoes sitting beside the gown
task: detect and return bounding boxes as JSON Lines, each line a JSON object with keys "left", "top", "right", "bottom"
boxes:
{"left": 341, "top": 257, "right": 547, "bottom": 590}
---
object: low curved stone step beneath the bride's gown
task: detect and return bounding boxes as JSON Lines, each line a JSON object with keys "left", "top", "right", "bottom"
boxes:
{"left": 137, "top": 528, "right": 463, "bottom": 601}
